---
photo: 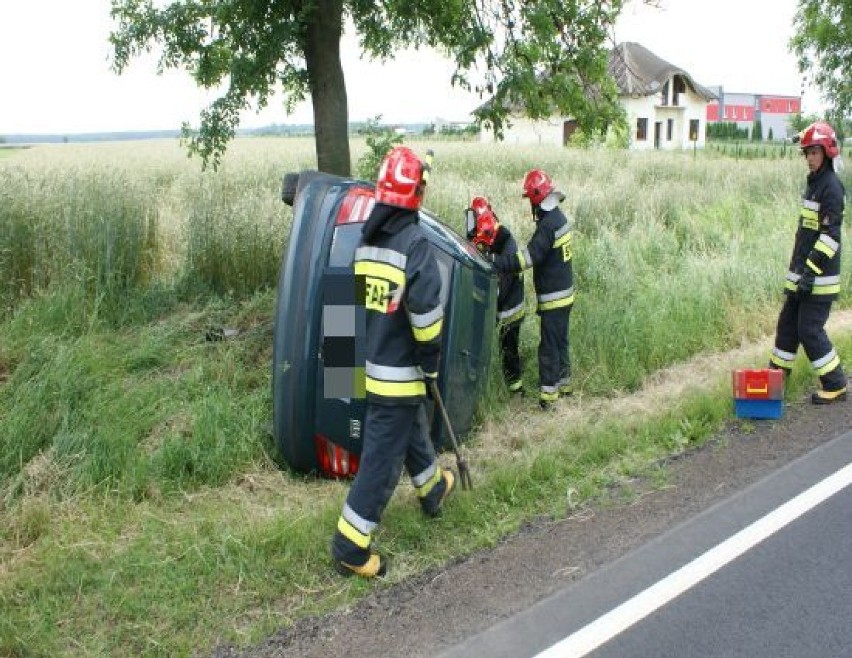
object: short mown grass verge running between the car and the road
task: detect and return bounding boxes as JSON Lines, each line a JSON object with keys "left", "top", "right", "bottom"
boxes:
{"left": 0, "top": 374, "right": 729, "bottom": 656}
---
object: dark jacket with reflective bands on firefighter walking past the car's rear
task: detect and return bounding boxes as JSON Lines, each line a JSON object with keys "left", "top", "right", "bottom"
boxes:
{"left": 355, "top": 203, "right": 444, "bottom": 404}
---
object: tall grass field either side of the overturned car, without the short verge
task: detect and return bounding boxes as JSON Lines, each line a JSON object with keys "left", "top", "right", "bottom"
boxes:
{"left": 0, "top": 140, "right": 852, "bottom": 499}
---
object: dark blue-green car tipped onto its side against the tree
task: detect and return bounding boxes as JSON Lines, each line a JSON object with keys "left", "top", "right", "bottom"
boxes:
{"left": 272, "top": 171, "right": 497, "bottom": 478}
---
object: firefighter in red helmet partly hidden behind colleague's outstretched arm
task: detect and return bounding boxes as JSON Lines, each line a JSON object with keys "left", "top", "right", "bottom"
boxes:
{"left": 467, "top": 196, "right": 526, "bottom": 396}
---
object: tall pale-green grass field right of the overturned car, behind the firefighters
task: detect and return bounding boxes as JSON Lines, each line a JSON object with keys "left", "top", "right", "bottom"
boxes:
{"left": 427, "top": 144, "right": 852, "bottom": 394}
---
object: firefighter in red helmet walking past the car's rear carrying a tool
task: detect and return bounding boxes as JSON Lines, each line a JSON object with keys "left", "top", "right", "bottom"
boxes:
{"left": 331, "top": 146, "right": 455, "bottom": 578}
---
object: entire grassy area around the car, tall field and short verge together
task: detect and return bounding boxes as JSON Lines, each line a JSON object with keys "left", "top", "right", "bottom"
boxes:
{"left": 0, "top": 140, "right": 852, "bottom": 656}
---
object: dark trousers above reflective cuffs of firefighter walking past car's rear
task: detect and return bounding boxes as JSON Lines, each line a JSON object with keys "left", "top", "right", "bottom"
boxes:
{"left": 346, "top": 403, "right": 438, "bottom": 524}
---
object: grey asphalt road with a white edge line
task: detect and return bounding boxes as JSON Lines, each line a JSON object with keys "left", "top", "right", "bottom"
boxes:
{"left": 440, "top": 432, "right": 852, "bottom": 658}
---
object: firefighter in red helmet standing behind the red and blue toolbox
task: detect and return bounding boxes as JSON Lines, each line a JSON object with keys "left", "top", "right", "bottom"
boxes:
{"left": 770, "top": 121, "right": 846, "bottom": 404}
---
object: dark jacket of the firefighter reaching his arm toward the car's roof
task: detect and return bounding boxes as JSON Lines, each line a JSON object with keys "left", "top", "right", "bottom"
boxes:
{"left": 494, "top": 207, "right": 574, "bottom": 313}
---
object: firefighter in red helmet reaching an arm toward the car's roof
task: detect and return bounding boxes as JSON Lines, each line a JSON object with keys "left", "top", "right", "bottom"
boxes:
{"left": 494, "top": 169, "right": 574, "bottom": 409}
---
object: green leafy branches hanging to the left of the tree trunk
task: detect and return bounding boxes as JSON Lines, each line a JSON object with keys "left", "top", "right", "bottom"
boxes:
{"left": 110, "top": 0, "right": 312, "bottom": 169}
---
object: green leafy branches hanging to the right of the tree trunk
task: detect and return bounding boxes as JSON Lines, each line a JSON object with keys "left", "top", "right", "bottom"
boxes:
{"left": 349, "top": 0, "right": 623, "bottom": 140}
